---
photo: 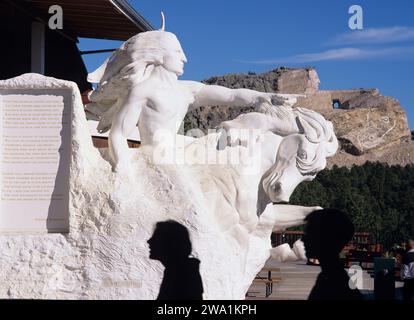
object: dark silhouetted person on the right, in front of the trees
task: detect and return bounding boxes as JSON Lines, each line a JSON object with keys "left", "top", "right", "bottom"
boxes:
{"left": 303, "top": 209, "right": 362, "bottom": 300}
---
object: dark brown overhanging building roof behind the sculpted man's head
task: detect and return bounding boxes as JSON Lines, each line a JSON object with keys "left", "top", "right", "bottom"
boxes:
{"left": 13, "top": 0, "right": 154, "bottom": 40}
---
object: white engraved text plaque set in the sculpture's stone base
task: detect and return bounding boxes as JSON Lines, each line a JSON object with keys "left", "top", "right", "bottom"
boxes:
{"left": 0, "top": 89, "right": 72, "bottom": 232}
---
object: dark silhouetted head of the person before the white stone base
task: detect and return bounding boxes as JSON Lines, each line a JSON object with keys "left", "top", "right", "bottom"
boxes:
{"left": 148, "top": 220, "right": 192, "bottom": 265}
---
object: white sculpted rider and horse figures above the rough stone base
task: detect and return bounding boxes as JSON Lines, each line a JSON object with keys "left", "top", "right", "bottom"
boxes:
{"left": 87, "top": 14, "right": 338, "bottom": 262}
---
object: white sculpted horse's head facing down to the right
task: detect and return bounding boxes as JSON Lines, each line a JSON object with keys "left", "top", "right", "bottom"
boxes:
{"left": 263, "top": 134, "right": 325, "bottom": 203}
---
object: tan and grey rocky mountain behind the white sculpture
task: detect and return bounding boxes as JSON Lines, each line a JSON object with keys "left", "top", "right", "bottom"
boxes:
{"left": 185, "top": 68, "right": 414, "bottom": 166}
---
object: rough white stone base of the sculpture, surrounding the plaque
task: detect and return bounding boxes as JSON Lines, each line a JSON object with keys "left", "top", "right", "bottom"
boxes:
{"left": 0, "top": 74, "right": 315, "bottom": 299}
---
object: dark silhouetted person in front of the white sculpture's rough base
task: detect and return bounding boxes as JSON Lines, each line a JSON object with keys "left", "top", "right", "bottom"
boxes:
{"left": 148, "top": 220, "right": 203, "bottom": 300}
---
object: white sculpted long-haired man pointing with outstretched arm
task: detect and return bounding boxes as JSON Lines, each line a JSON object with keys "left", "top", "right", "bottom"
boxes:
{"left": 87, "top": 14, "right": 274, "bottom": 171}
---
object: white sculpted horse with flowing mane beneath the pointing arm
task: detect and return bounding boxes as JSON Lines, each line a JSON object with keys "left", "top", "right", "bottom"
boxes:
{"left": 182, "top": 106, "right": 338, "bottom": 220}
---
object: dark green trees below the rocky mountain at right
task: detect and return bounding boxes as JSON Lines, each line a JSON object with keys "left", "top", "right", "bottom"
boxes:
{"left": 291, "top": 162, "right": 414, "bottom": 246}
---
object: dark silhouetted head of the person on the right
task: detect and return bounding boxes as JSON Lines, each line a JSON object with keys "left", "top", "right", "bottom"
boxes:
{"left": 303, "top": 209, "right": 354, "bottom": 263}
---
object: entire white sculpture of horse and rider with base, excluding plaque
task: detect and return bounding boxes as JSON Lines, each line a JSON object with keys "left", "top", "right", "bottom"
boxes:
{"left": 0, "top": 15, "right": 338, "bottom": 299}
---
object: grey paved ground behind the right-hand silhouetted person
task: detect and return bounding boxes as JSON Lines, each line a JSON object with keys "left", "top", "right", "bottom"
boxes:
{"left": 247, "top": 260, "right": 382, "bottom": 300}
